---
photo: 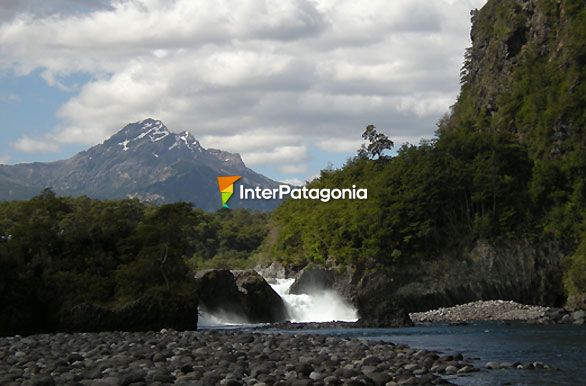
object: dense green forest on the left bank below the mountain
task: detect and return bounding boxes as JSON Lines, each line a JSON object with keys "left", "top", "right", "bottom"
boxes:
{"left": 0, "top": 190, "right": 267, "bottom": 331}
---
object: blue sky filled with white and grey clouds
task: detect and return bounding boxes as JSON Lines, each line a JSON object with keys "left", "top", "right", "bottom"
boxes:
{"left": 0, "top": 0, "right": 486, "bottom": 183}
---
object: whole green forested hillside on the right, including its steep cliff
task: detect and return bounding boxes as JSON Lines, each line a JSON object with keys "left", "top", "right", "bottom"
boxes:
{"left": 266, "top": 0, "right": 586, "bottom": 307}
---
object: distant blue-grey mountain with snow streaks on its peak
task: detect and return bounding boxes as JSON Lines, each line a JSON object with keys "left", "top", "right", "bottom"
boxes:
{"left": 0, "top": 118, "right": 279, "bottom": 210}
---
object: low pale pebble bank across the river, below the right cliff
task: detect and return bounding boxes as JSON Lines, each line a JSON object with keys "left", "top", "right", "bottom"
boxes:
{"left": 409, "top": 300, "right": 586, "bottom": 324}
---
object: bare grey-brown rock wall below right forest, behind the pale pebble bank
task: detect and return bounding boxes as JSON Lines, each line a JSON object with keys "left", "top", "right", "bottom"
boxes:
{"left": 394, "top": 240, "right": 565, "bottom": 312}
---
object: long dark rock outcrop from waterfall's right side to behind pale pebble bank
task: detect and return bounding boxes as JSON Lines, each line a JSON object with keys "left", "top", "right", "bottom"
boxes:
{"left": 290, "top": 240, "right": 565, "bottom": 327}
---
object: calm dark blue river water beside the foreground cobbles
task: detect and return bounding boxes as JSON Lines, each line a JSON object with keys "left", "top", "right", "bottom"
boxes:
{"left": 266, "top": 322, "right": 586, "bottom": 386}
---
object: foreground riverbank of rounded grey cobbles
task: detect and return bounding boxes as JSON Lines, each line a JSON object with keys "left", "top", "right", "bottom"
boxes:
{"left": 0, "top": 330, "right": 476, "bottom": 386}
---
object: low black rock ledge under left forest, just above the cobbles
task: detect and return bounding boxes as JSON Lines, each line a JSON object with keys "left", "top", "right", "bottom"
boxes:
{"left": 57, "top": 294, "right": 198, "bottom": 332}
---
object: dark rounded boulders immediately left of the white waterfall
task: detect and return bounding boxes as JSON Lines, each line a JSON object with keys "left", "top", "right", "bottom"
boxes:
{"left": 195, "top": 269, "right": 289, "bottom": 323}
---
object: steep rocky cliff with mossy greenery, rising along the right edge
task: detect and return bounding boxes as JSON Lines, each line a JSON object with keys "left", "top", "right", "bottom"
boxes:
{"left": 439, "top": 0, "right": 586, "bottom": 307}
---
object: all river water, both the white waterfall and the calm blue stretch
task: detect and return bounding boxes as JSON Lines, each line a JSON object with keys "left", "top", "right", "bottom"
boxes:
{"left": 198, "top": 279, "right": 586, "bottom": 386}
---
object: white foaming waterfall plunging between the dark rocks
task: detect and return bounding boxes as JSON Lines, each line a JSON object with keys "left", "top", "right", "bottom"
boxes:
{"left": 269, "top": 279, "right": 358, "bottom": 323}
